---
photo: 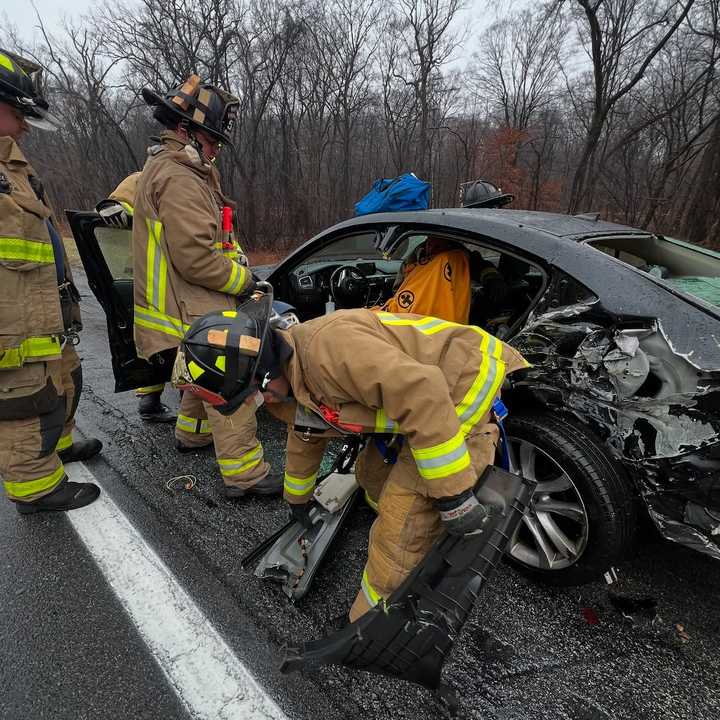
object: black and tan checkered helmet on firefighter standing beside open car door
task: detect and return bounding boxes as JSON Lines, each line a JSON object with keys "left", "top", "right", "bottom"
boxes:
{"left": 142, "top": 75, "right": 240, "bottom": 144}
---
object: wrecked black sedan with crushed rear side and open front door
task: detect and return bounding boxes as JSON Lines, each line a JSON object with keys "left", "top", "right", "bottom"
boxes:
{"left": 68, "top": 209, "right": 720, "bottom": 585}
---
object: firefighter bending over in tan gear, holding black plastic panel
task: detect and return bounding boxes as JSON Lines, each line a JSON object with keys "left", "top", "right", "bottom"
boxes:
{"left": 176, "top": 298, "right": 527, "bottom": 621}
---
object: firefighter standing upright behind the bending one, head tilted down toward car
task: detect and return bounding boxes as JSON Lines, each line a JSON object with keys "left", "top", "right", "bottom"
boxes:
{"left": 133, "top": 75, "right": 282, "bottom": 497}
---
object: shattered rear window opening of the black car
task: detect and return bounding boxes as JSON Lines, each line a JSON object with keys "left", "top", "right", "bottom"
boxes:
{"left": 588, "top": 235, "right": 720, "bottom": 307}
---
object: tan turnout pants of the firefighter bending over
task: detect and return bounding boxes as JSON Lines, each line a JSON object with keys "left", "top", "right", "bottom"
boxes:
{"left": 350, "top": 423, "right": 498, "bottom": 622}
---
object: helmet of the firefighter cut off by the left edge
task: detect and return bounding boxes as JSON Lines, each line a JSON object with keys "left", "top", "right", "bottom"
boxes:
{"left": 0, "top": 48, "right": 60, "bottom": 130}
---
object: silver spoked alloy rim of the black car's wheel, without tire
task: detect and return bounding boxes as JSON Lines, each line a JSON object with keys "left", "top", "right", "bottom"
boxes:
{"left": 508, "top": 437, "right": 589, "bottom": 570}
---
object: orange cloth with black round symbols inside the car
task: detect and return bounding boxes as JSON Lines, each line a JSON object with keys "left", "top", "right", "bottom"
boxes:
{"left": 382, "top": 250, "right": 470, "bottom": 325}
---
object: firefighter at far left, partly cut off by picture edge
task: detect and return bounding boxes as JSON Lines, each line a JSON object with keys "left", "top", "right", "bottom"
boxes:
{"left": 0, "top": 50, "right": 102, "bottom": 514}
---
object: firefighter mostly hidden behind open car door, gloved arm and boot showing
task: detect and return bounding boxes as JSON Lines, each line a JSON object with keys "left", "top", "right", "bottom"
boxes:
{"left": 95, "top": 172, "right": 177, "bottom": 423}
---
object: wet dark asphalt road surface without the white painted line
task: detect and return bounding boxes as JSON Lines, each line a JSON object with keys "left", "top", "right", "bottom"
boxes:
{"left": 0, "top": 270, "right": 720, "bottom": 720}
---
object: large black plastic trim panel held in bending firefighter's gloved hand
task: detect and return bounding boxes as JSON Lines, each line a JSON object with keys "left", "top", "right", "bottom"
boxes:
{"left": 281, "top": 467, "right": 535, "bottom": 690}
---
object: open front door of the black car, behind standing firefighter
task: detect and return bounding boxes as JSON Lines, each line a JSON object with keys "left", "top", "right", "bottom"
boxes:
{"left": 65, "top": 210, "right": 174, "bottom": 392}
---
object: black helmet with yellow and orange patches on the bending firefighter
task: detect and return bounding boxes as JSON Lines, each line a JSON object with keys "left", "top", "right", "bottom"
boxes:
{"left": 173, "top": 286, "right": 272, "bottom": 414}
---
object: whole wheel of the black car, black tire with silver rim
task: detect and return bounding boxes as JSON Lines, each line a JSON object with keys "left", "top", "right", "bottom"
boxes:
{"left": 506, "top": 413, "right": 635, "bottom": 586}
